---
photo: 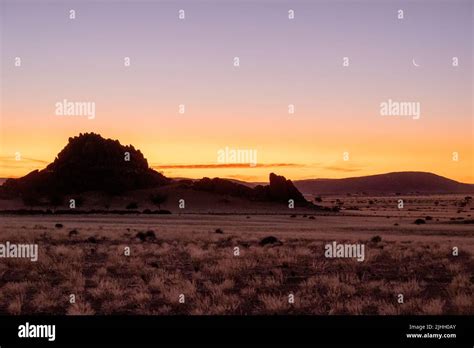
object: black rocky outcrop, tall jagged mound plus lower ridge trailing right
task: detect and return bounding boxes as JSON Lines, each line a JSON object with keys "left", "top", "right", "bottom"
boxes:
{"left": 0, "top": 133, "right": 308, "bottom": 206}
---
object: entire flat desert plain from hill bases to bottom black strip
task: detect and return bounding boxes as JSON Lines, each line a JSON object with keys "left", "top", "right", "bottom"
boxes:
{"left": 0, "top": 194, "right": 474, "bottom": 315}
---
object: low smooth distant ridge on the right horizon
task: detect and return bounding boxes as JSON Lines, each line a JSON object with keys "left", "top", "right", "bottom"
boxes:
{"left": 294, "top": 172, "right": 474, "bottom": 195}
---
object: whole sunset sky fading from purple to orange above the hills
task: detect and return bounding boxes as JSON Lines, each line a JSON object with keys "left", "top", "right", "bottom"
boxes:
{"left": 0, "top": 0, "right": 474, "bottom": 183}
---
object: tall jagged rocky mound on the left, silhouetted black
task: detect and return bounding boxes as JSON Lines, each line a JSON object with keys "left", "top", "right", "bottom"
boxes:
{"left": 2, "top": 133, "right": 170, "bottom": 200}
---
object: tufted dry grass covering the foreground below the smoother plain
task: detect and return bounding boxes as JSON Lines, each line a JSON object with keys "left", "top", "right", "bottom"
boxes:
{"left": 0, "top": 204, "right": 474, "bottom": 315}
